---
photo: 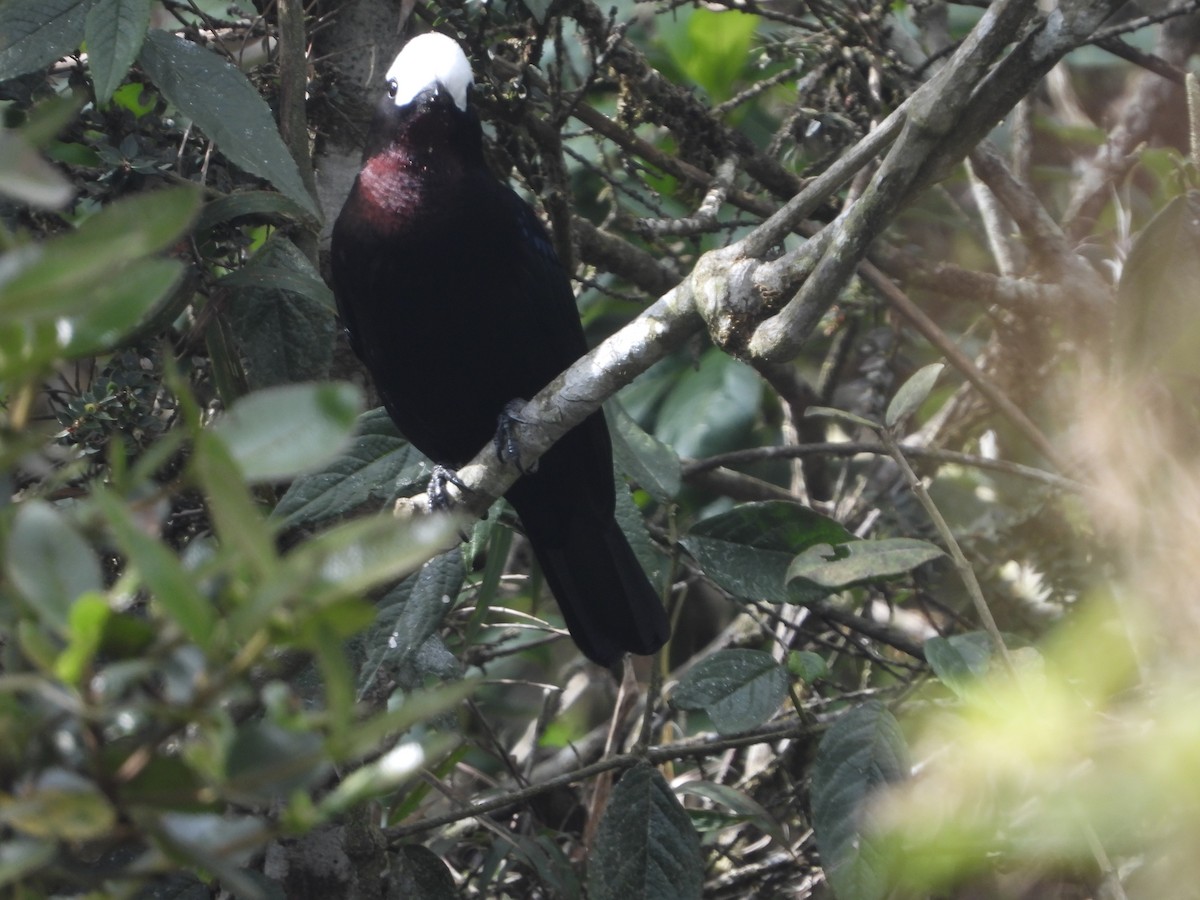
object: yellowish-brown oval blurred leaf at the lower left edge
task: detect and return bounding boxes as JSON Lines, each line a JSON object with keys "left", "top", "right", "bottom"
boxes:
{"left": 0, "top": 769, "right": 116, "bottom": 841}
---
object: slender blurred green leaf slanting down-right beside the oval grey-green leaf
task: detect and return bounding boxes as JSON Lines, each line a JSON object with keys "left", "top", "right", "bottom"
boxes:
{"left": 92, "top": 486, "right": 216, "bottom": 647}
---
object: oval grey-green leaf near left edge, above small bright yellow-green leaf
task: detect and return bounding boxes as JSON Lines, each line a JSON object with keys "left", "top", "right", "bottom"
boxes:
{"left": 5, "top": 500, "right": 104, "bottom": 635}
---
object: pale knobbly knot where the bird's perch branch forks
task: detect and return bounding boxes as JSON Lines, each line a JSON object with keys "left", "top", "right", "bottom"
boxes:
{"left": 691, "top": 247, "right": 775, "bottom": 356}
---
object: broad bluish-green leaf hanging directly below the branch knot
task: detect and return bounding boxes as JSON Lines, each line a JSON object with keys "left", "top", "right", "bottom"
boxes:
{"left": 654, "top": 348, "right": 762, "bottom": 457}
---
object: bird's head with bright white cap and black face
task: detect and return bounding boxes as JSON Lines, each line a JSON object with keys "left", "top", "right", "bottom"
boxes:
{"left": 366, "top": 32, "right": 481, "bottom": 164}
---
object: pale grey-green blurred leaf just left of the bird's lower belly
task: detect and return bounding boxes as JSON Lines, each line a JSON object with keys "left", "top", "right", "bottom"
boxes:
{"left": 212, "top": 382, "right": 362, "bottom": 481}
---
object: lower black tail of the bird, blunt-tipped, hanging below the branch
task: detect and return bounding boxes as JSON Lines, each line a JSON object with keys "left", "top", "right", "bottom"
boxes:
{"left": 517, "top": 510, "right": 671, "bottom": 666}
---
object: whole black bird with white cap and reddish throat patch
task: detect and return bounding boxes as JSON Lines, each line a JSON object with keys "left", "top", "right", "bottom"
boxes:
{"left": 332, "top": 34, "right": 670, "bottom": 666}
